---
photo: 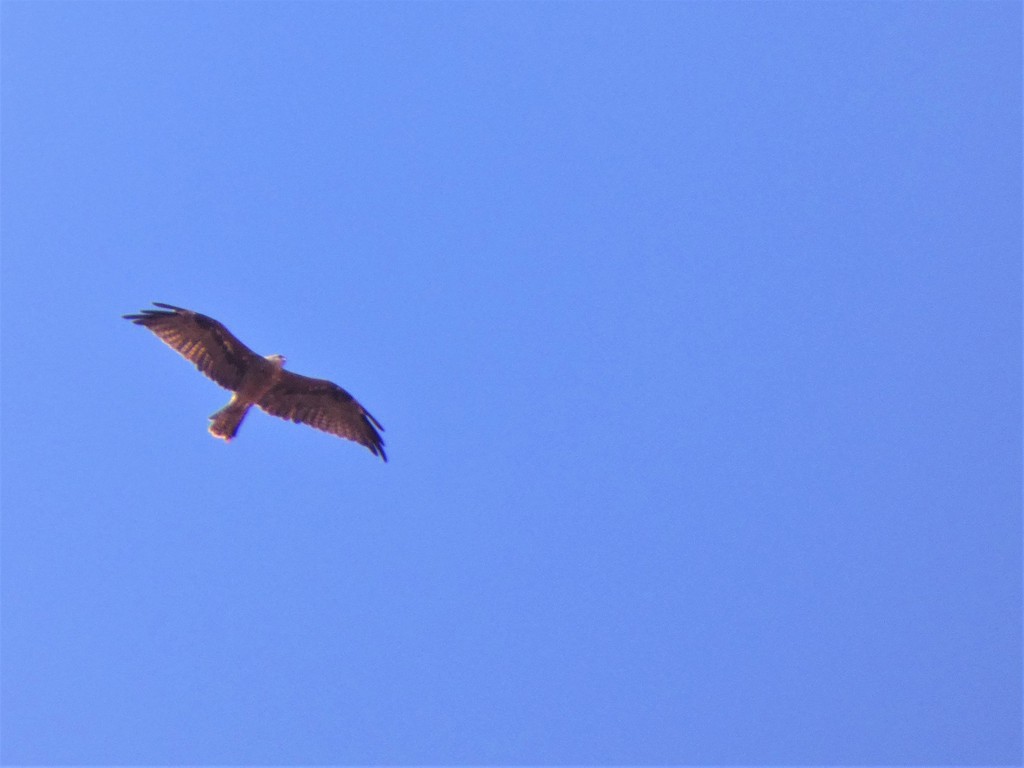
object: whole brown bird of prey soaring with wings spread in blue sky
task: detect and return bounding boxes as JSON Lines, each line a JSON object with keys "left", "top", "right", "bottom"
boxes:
{"left": 123, "top": 301, "right": 387, "bottom": 461}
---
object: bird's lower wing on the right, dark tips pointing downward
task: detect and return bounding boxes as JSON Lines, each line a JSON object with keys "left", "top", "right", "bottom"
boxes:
{"left": 256, "top": 371, "right": 387, "bottom": 461}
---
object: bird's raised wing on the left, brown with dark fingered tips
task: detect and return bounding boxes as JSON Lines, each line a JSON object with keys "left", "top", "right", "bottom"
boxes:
{"left": 123, "top": 301, "right": 259, "bottom": 390}
